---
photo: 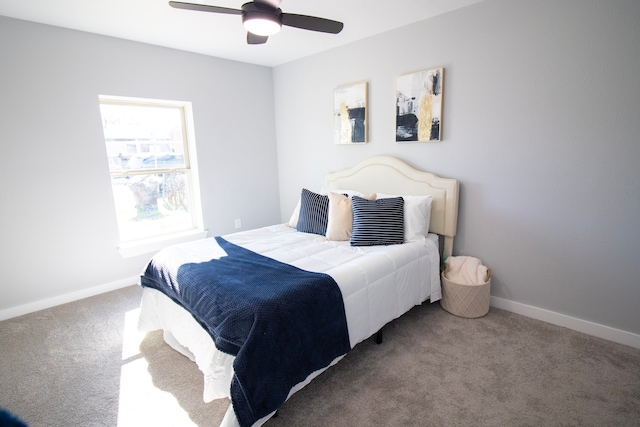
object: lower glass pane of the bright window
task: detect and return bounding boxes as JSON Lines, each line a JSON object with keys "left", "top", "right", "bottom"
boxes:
{"left": 111, "top": 172, "right": 193, "bottom": 241}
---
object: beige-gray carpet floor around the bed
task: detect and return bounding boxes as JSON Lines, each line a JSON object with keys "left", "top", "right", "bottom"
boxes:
{"left": 0, "top": 286, "right": 640, "bottom": 427}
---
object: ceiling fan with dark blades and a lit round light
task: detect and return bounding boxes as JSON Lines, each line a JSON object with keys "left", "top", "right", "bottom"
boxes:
{"left": 169, "top": 0, "right": 344, "bottom": 44}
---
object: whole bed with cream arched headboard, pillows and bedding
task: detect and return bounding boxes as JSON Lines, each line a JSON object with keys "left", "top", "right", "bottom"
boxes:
{"left": 139, "top": 156, "right": 458, "bottom": 427}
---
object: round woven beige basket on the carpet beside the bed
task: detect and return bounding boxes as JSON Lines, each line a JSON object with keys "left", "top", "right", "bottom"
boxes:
{"left": 440, "top": 269, "right": 491, "bottom": 319}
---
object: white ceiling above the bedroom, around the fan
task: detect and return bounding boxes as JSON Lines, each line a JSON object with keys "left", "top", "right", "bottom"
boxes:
{"left": 0, "top": 0, "right": 481, "bottom": 66}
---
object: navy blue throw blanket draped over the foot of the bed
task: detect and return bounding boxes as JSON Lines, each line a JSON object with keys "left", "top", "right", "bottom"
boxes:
{"left": 141, "top": 237, "right": 351, "bottom": 426}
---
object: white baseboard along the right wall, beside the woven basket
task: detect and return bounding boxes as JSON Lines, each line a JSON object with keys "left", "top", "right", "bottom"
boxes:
{"left": 491, "top": 296, "right": 640, "bottom": 348}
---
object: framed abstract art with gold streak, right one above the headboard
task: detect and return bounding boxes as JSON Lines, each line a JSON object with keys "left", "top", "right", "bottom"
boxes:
{"left": 396, "top": 68, "right": 444, "bottom": 141}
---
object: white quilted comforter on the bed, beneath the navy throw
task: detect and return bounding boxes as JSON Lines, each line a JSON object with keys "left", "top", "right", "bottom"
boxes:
{"left": 139, "top": 224, "right": 441, "bottom": 425}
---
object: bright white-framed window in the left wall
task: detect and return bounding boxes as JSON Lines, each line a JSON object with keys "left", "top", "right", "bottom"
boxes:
{"left": 100, "top": 96, "right": 202, "bottom": 249}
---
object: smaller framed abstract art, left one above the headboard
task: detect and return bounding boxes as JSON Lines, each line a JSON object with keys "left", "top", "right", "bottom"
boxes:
{"left": 333, "top": 82, "right": 368, "bottom": 144}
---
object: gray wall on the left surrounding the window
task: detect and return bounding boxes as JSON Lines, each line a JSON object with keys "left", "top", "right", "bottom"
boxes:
{"left": 0, "top": 17, "right": 280, "bottom": 310}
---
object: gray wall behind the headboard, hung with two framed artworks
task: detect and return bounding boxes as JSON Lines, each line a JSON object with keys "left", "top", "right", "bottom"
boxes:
{"left": 274, "top": 0, "right": 640, "bottom": 334}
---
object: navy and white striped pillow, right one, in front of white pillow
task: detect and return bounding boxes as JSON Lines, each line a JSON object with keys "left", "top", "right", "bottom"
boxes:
{"left": 351, "top": 196, "right": 404, "bottom": 246}
